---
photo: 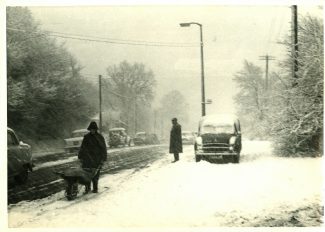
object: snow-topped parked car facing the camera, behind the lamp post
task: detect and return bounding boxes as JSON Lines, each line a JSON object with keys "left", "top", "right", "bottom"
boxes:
{"left": 194, "top": 115, "right": 242, "bottom": 163}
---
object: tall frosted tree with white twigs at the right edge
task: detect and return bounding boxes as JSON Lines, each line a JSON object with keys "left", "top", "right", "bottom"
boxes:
{"left": 272, "top": 16, "right": 324, "bottom": 155}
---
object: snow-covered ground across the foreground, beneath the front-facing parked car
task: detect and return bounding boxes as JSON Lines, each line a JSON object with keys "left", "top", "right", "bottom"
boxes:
{"left": 8, "top": 141, "right": 323, "bottom": 228}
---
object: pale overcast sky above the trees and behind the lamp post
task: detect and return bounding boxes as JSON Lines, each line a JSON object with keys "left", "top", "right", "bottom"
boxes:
{"left": 3, "top": 1, "right": 322, "bottom": 129}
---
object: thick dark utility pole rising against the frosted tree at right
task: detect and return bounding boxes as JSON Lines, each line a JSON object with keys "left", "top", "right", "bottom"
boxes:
{"left": 291, "top": 5, "right": 298, "bottom": 79}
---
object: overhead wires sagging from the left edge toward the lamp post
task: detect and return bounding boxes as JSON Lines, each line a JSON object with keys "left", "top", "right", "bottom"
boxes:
{"left": 7, "top": 27, "right": 199, "bottom": 47}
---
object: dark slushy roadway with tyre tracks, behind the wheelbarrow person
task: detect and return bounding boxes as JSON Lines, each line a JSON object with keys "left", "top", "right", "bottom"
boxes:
{"left": 8, "top": 145, "right": 167, "bottom": 204}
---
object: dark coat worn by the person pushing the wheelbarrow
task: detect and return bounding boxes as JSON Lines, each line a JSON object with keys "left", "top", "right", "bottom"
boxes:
{"left": 78, "top": 132, "right": 107, "bottom": 168}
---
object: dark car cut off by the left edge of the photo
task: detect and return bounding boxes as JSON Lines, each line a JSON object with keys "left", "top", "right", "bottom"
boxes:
{"left": 7, "top": 128, "right": 34, "bottom": 184}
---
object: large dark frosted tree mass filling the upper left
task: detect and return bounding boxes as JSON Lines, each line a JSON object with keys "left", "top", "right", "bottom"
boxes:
{"left": 7, "top": 7, "right": 94, "bottom": 139}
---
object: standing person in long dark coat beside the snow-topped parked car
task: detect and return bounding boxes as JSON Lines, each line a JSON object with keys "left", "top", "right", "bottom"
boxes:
{"left": 169, "top": 118, "right": 183, "bottom": 162}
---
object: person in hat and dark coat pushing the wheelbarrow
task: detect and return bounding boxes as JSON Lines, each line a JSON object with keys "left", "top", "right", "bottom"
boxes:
{"left": 78, "top": 122, "right": 107, "bottom": 193}
